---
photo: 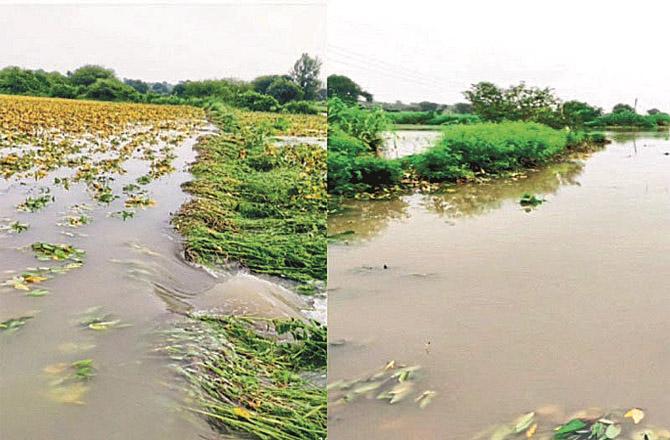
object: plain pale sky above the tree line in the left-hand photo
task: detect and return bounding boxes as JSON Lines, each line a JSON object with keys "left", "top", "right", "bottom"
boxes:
{"left": 0, "top": 0, "right": 326, "bottom": 83}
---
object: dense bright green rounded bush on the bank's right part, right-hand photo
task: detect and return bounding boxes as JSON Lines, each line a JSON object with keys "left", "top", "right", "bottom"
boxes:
{"left": 406, "top": 122, "right": 568, "bottom": 181}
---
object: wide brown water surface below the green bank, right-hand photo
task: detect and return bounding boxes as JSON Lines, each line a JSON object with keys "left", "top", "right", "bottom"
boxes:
{"left": 329, "top": 134, "right": 670, "bottom": 440}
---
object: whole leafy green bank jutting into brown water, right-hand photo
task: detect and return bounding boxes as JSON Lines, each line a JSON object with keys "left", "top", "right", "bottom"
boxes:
{"left": 328, "top": 99, "right": 606, "bottom": 196}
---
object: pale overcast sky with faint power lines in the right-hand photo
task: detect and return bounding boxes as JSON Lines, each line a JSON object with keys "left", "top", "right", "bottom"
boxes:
{"left": 327, "top": 0, "right": 670, "bottom": 111}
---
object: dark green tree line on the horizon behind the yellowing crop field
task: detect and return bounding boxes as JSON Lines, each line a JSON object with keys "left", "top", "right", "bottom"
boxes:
{"left": 0, "top": 54, "right": 325, "bottom": 113}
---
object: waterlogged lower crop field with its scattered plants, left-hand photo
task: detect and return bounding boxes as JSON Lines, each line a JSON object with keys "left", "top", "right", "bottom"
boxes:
{"left": 0, "top": 97, "right": 324, "bottom": 440}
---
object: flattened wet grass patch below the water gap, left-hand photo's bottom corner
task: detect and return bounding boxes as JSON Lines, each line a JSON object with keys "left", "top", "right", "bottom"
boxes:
{"left": 166, "top": 313, "right": 327, "bottom": 440}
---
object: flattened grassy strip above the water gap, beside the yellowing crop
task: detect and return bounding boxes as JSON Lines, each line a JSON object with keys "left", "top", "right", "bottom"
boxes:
{"left": 174, "top": 107, "right": 327, "bottom": 282}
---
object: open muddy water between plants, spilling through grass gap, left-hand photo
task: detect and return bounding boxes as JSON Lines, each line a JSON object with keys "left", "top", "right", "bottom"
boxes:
{"left": 0, "top": 130, "right": 324, "bottom": 440}
